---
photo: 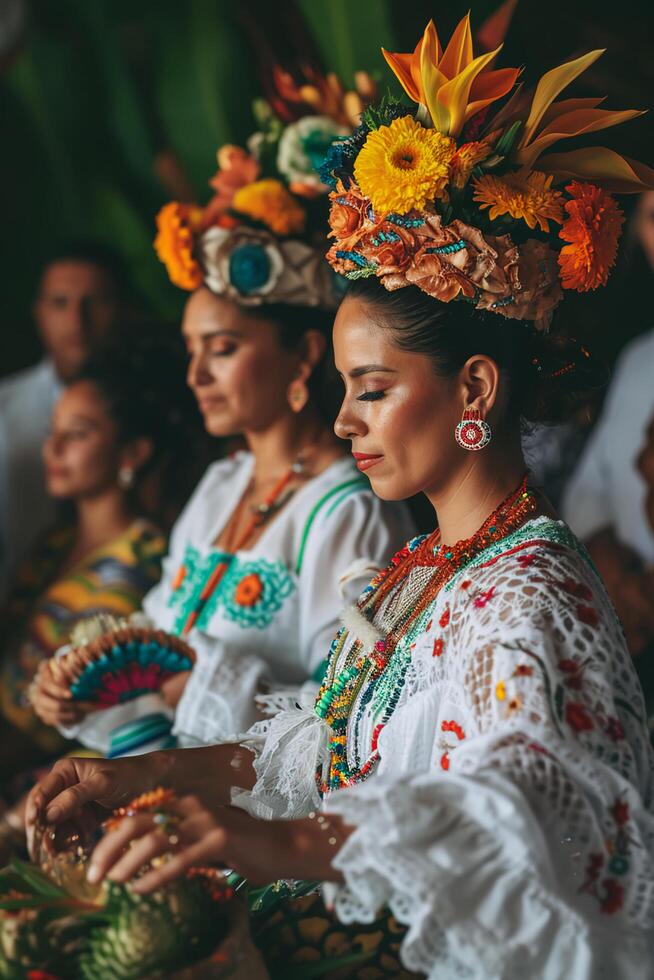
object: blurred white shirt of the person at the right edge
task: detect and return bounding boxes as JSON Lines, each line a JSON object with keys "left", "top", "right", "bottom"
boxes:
{"left": 562, "top": 330, "right": 654, "bottom": 564}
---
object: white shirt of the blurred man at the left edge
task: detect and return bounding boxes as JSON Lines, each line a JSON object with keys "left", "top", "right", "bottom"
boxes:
{"left": 0, "top": 360, "right": 63, "bottom": 601}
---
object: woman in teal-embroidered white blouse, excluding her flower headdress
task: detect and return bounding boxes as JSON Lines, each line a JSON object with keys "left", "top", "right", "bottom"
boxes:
{"left": 32, "top": 287, "right": 412, "bottom": 755}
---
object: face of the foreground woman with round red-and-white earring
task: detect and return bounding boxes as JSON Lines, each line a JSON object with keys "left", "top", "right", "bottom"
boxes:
{"left": 334, "top": 299, "right": 462, "bottom": 500}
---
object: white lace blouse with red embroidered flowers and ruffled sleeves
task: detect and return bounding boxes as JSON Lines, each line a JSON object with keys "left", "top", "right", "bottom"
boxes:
{"left": 240, "top": 517, "right": 654, "bottom": 980}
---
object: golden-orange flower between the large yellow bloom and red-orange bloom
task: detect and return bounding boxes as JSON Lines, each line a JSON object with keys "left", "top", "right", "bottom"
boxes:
{"left": 473, "top": 170, "right": 564, "bottom": 231}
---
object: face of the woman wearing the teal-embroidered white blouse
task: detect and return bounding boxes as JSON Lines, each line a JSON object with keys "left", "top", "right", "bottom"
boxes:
{"left": 182, "top": 289, "right": 299, "bottom": 436}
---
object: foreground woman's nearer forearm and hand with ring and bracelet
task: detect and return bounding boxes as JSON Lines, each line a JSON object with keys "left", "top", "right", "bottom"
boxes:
{"left": 88, "top": 796, "right": 348, "bottom": 894}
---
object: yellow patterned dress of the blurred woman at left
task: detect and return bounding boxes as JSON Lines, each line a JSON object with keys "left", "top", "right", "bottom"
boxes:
{"left": 0, "top": 520, "right": 166, "bottom": 753}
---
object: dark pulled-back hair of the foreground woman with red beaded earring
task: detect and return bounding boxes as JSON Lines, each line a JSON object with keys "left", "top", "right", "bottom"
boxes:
{"left": 347, "top": 278, "right": 607, "bottom": 423}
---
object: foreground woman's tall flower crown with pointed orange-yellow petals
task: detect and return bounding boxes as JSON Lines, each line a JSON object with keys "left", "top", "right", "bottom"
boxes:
{"left": 321, "top": 16, "right": 654, "bottom": 329}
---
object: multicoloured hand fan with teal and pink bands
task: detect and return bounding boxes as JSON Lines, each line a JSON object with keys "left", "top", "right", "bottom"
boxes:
{"left": 42, "top": 616, "right": 196, "bottom": 708}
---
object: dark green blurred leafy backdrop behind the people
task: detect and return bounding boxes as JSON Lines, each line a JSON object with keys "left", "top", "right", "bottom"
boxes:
{"left": 0, "top": 0, "right": 654, "bottom": 374}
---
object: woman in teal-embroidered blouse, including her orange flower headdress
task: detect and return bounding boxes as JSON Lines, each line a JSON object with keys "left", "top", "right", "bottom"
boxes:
{"left": 29, "top": 76, "right": 412, "bottom": 755}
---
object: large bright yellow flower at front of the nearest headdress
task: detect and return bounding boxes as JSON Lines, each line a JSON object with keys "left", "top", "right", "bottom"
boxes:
{"left": 354, "top": 116, "right": 456, "bottom": 217}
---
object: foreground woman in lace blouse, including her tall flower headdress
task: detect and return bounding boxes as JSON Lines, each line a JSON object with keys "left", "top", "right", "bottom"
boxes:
{"left": 30, "top": 18, "right": 654, "bottom": 980}
